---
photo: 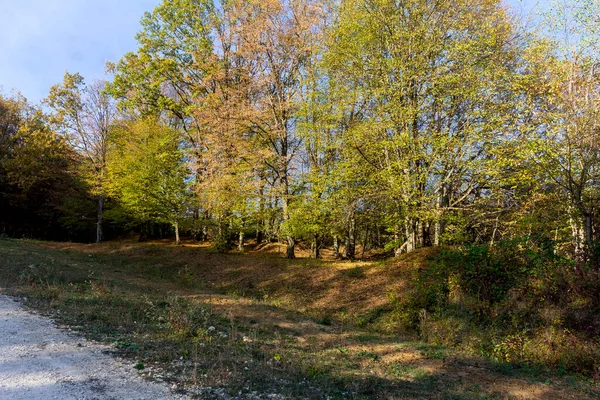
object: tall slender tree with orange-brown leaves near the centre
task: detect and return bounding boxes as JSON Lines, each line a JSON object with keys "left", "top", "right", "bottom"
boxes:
{"left": 229, "top": 0, "right": 323, "bottom": 258}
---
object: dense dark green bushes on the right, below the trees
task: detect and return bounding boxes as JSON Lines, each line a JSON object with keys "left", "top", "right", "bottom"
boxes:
{"left": 395, "top": 238, "right": 600, "bottom": 376}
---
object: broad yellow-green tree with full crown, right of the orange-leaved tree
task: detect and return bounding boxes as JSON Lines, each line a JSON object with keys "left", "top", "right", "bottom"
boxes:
{"left": 327, "top": 0, "right": 517, "bottom": 254}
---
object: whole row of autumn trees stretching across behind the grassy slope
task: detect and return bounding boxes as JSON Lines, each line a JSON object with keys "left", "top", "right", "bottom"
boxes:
{"left": 0, "top": 0, "right": 600, "bottom": 265}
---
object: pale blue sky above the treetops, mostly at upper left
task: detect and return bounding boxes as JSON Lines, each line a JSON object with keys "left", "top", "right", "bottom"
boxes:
{"left": 0, "top": 0, "right": 546, "bottom": 103}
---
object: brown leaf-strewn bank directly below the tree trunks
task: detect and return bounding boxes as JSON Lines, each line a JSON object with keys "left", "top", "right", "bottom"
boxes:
{"left": 43, "top": 242, "right": 430, "bottom": 326}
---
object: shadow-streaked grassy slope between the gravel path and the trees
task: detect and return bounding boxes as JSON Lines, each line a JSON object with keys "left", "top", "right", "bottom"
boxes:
{"left": 0, "top": 240, "right": 600, "bottom": 399}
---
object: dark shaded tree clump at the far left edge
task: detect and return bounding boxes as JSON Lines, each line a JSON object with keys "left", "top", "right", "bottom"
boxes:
{"left": 0, "top": 92, "right": 87, "bottom": 240}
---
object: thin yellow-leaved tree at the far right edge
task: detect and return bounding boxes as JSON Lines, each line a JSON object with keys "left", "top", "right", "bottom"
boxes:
{"left": 540, "top": 0, "right": 600, "bottom": 258}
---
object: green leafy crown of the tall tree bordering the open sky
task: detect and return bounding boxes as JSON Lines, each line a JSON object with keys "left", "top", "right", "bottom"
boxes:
{"left": 109, "top": 0, "right": 214, "bottom": 117}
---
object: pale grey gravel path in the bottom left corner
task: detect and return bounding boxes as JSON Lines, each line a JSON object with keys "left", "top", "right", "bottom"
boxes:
{"left": 0, "top": 295, "right": 186, "bottom": 400}
